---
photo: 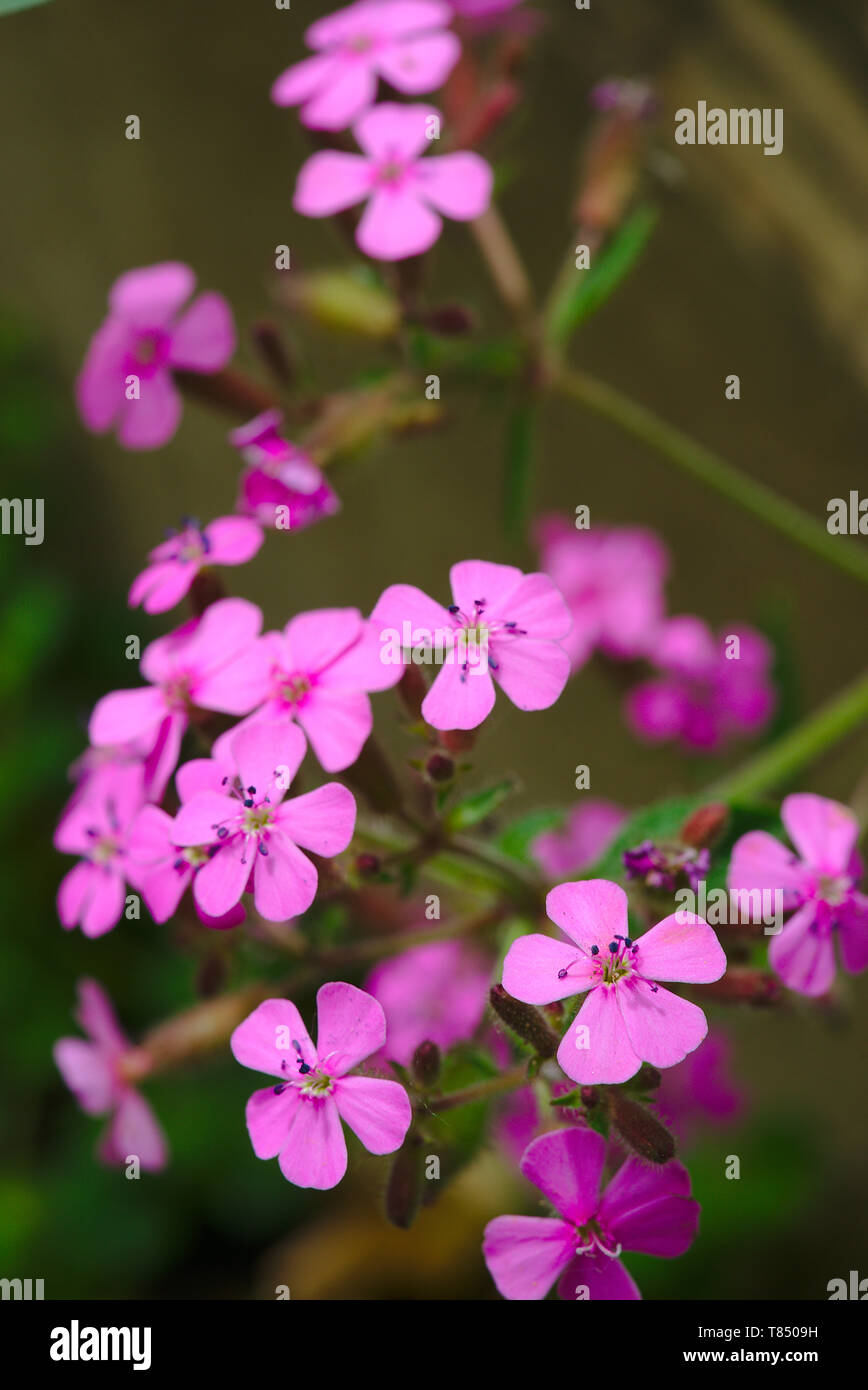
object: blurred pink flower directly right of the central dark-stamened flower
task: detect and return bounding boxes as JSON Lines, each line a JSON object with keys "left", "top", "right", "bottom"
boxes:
{"left": 537, "top": 516, "right": 669, "bottom": 670}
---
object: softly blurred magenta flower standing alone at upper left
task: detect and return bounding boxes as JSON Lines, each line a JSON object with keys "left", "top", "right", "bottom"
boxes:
{"left": 77, "top": 261, "right": 235, "bottom": 449}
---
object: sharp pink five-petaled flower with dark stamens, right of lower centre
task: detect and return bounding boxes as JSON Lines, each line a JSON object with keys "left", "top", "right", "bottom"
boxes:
{"left": 504, "top": 878, "right": 726, "bottom": 1086}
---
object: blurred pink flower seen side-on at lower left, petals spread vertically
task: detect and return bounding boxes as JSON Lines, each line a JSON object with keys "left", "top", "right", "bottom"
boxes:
{"left": 54, "top": 980, "right": 167, "bottom": 1172}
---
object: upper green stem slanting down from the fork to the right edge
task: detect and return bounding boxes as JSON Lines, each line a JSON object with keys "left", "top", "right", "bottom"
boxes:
{"left": 555, "top": 368, "right": 868, "bottom": 584}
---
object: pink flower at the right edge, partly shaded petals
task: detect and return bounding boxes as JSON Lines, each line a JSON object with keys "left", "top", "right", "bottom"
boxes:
{"left": 729, "top": 792, "right": 868, "bottom": 997}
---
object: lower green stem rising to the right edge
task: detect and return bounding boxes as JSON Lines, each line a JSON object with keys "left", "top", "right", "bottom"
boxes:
{"left": 708, "top": 673, "right": 868, "bottom": 799}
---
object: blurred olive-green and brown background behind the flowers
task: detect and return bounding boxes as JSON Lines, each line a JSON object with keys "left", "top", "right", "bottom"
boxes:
{"left": 0, "top": 0, "right": 868, "bottom": 1300}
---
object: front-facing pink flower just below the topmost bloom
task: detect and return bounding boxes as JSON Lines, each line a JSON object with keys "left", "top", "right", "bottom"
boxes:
{"left": 294, "top": 101, "right": 492, "bottom": 261}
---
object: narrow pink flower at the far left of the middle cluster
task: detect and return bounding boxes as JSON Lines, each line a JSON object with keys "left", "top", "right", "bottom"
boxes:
{"left": 54, "top": 763, "right": 145, "bottom": 937}
